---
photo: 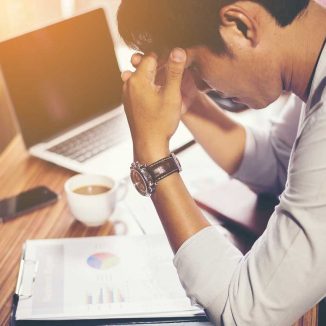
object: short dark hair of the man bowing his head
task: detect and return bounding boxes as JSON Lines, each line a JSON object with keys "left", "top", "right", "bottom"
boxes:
{"left": 118, "top": 0, "right": 310, "bottom": 54}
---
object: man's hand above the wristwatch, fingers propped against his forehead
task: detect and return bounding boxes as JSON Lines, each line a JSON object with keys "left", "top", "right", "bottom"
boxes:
{"left": 122, "top": 48, "right": 186, "bottom": 163}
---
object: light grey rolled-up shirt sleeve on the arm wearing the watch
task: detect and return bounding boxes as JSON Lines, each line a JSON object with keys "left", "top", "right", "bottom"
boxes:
{"left": 174, "top": 100, "right": 326, "bottom": 326}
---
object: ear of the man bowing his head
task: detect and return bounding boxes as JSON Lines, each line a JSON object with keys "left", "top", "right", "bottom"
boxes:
{"left": 219, "top": 5, "right": 259, "bottom": 47}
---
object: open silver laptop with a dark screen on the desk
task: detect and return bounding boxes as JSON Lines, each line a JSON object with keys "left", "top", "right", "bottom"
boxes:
{"left": 0, "top": 8, "right": 194, "bottom": 179}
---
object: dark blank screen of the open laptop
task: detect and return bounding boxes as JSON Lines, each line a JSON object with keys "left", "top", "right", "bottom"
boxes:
{"left": 0, "top": 9, "right": 122, "bottom": 147}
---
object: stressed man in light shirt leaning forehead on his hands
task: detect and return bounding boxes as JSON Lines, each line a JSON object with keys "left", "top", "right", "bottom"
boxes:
{"left": 118, "top": 0, "right": 326, "bottom": 326}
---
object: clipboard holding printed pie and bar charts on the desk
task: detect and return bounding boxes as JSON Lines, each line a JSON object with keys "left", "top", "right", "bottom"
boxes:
{"left": 10, "top": 236, "right": 210, "bottom": 326}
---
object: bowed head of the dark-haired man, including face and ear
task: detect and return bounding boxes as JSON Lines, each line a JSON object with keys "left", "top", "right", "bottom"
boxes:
{"left": 118, "top": 0, "right": 309, "bottom": 108}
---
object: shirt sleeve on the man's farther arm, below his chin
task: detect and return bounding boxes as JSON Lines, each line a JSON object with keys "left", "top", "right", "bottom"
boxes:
{"left": 233, "top": 95, "right": 302, "bottom": 195}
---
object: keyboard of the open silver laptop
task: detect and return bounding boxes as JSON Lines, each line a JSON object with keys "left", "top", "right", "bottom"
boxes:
{"left": 48, "top": 115, "right": 129, "bottom": 163}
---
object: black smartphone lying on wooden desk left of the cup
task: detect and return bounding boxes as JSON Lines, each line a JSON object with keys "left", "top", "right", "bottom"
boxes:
{"left": 0, "top": 186, "right": 58, "bottom": 222}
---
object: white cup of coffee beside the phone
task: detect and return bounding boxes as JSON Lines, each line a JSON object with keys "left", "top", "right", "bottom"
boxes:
{"left": 64, "top": 174, "right": 128, "bottom": 227}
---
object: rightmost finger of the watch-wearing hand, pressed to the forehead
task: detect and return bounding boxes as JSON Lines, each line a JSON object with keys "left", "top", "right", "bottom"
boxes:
{"left": 164, "top": 48, "right": 187, "bottom": 96}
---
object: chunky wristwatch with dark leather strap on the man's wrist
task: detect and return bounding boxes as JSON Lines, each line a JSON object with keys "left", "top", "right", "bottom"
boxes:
{"left": 130, "top": 153, "right": 181, "bottom": 196}
